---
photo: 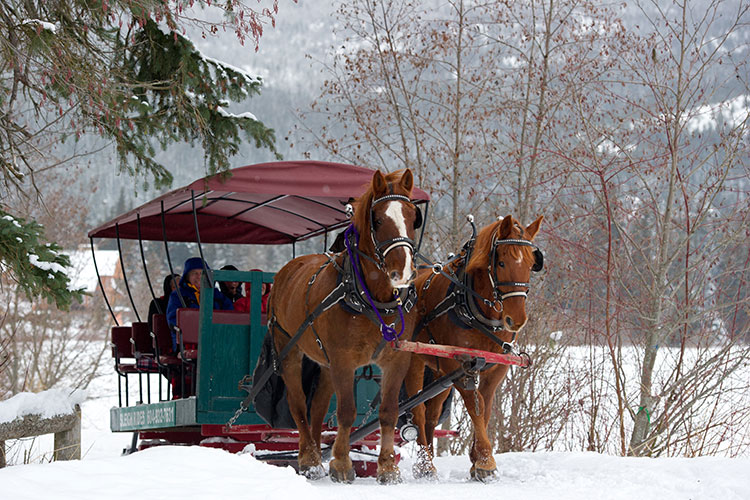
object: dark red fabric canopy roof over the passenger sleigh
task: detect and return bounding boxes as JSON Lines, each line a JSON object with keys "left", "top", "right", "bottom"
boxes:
{"left": 89, "top": 161, "right": 430, "bottom": 245}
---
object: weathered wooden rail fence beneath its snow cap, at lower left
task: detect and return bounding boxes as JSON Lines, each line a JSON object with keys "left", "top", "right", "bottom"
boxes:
{"left": 0, "top": 405, "right": 81, "bottom": 468}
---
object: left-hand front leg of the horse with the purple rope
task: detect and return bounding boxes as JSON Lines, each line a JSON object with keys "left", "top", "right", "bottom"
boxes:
{"left": 328, "top": 363, "right": 357, "bottom": 483}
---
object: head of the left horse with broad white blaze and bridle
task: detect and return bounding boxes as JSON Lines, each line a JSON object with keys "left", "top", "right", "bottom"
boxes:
{"left": 354, "top": 168, "right": 417, "bottom": 289}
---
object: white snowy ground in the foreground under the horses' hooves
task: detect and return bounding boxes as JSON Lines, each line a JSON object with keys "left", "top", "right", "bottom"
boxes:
{"left": 0, "top": 377, "right": 750, "bottom": 500}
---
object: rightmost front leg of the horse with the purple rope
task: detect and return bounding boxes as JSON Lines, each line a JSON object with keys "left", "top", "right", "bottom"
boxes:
{"left": 377, "top": 353, "right": 411, "bottom": 484}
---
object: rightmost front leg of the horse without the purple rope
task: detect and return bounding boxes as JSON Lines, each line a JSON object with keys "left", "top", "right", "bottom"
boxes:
{"left": 464, "top": 366, "right": 509, "bottom": 482}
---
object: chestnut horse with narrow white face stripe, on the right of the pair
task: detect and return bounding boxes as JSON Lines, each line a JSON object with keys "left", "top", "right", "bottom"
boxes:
{"left": 406, "top": 215, "right": 543, "bottom": 481}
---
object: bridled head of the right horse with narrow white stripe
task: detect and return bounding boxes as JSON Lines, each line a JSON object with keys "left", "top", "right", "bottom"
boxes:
{"left": 466, "top": 215, "right": 544, "bottom": 332}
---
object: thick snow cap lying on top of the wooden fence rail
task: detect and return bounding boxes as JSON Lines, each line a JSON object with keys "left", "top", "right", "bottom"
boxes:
{"left": 0, "top": 389, "right": 86, "bottom": 424}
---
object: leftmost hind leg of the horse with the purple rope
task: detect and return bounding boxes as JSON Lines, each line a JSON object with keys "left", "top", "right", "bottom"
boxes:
{"left": 281, "top": 349, "right": 325, "bottom": 479}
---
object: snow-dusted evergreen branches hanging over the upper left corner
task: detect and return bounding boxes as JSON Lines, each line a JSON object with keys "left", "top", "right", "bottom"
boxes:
{"left": 0, "top": 0, "right": 278, "bottom": 307}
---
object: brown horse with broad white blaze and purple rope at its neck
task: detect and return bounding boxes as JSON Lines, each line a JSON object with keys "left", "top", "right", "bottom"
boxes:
{"left": 269, "top": 169, "right": 424, "bottom": 483}
